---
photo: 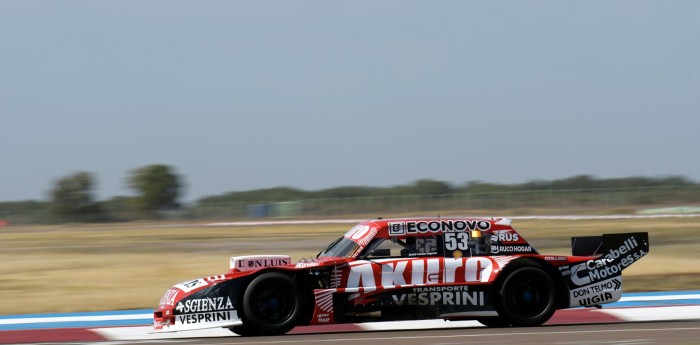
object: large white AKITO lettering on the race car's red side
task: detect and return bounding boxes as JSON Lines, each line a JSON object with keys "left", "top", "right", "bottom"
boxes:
{"left": 346, "top": 257, "right": 494, "bottom": 289}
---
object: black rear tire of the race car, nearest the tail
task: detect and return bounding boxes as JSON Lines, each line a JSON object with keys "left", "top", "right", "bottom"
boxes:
{"left": 496, "top": 266, "right": 556, "bottom": 327}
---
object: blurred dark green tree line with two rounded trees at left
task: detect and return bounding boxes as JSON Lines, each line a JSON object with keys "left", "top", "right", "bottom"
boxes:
{"left": 0, "top": 169, "right": 699, "bottom": 223}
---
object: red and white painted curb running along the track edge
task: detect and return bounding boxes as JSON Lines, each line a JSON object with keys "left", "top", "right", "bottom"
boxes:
{"left": 0, "top": 305, "right": 700, "bottom": 344}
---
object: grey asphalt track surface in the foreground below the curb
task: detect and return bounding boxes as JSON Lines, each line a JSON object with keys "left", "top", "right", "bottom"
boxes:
{"left": 83, "top": 320, "right": 700, "bottom": 345}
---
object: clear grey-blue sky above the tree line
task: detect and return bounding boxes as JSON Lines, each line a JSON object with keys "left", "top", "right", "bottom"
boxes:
{"left": 0, "top": 0, "right": 700, "bottom": 201}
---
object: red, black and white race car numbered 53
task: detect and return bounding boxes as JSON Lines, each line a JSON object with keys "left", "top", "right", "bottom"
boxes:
{"left": 154, "top": 218, "right": 649, "bottom": 335}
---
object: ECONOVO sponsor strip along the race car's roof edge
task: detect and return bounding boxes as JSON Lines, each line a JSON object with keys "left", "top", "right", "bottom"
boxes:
{"left": 388, "top": 220, "right": 491, "bottom": 236}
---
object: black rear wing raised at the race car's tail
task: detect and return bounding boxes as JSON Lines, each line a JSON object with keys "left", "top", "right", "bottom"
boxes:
{"left": 571, "top": 232, "right": 649, "bottom": 260}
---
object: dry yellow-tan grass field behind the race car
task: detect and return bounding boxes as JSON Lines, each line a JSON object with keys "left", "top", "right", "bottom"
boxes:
{"left": 0, "top": 218, "right": 700, "bottom": 314}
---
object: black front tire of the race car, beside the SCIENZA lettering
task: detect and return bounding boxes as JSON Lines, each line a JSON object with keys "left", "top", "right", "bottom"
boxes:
{"left": 241, "top": 272, "right": 303, "bottom": 335}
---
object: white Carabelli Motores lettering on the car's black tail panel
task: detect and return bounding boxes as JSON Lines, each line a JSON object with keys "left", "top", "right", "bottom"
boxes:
{"left": 571, "top": 236, "right": 646, "bottom": 286}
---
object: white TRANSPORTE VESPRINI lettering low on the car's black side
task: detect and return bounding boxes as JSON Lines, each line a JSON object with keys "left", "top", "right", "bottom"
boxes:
{"left": 391, "top": 286, "right": 485, "bottom": 306}
